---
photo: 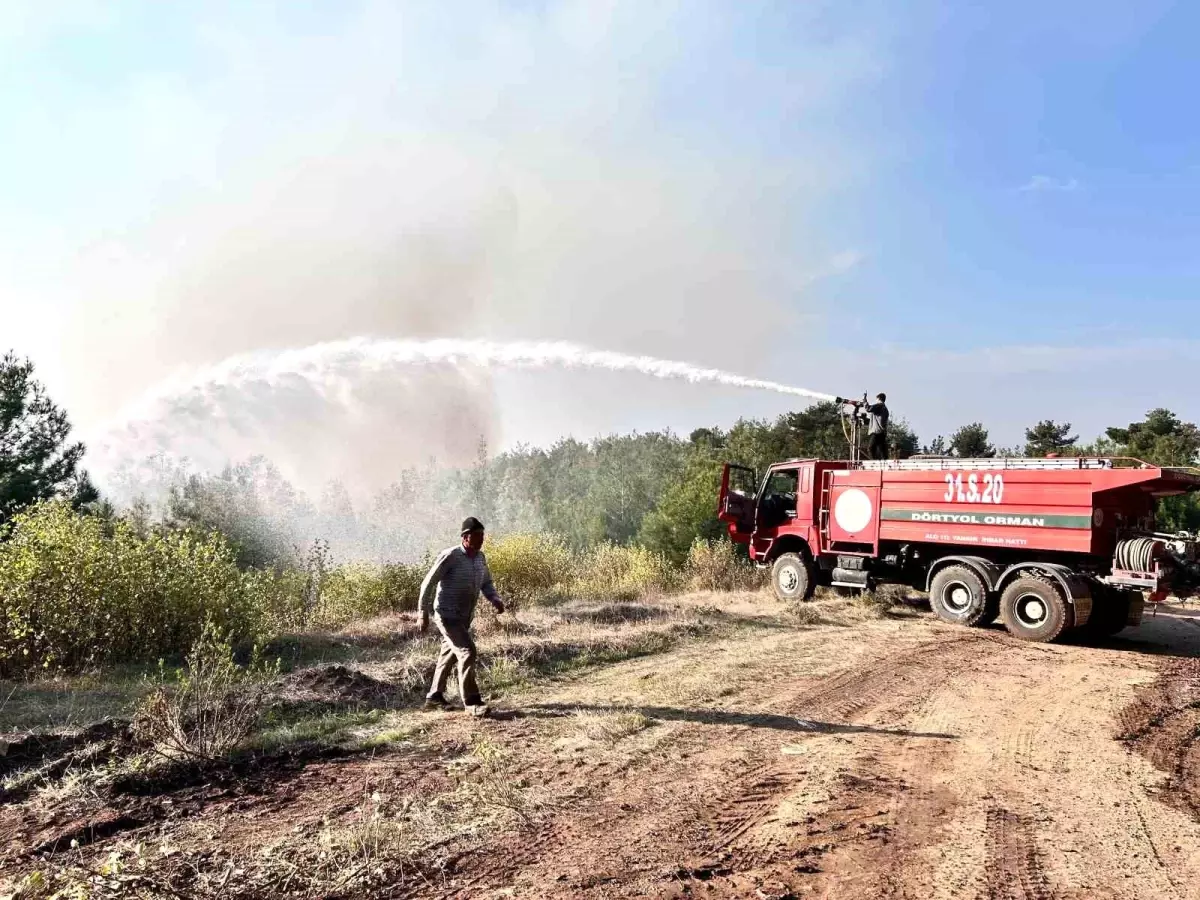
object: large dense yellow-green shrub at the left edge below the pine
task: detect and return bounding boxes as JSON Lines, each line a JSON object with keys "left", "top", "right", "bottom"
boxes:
{"left": 0, "top": 502, "right": 263, "bottom": 672}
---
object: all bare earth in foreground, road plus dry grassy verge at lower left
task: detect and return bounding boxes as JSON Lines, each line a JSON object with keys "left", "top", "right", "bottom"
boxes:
{"left": 7, "top": 593, "right": 1200, "bottom": 900}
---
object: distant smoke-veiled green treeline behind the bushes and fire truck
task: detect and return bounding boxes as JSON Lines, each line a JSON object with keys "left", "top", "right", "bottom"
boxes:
{"left": 108, "top": 403, "right": 1200, "bottom": 566}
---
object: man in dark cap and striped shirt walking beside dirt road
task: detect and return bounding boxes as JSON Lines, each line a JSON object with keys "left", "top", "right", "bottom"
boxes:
{"left": 416, "top": 516, "right": 504, "bottom": 716}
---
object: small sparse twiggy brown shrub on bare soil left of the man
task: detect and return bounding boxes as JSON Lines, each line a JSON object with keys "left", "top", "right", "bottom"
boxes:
{"left": 133, "top": 620, "right": 278, "bottom": 761}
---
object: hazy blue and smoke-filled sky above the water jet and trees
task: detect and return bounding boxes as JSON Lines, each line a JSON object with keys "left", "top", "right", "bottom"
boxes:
{"left": 0, "top": 0, "right": 1200, "bottom": 487}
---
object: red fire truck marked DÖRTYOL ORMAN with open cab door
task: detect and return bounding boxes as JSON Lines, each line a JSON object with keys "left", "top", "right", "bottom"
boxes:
{"left": 718, "top": 458, "right": 1200, "bottom": 642}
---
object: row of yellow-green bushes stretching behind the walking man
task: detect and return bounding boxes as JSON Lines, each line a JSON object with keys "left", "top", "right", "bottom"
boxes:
{"left": 0, "top": 500, "right": 758, "bottom": 677}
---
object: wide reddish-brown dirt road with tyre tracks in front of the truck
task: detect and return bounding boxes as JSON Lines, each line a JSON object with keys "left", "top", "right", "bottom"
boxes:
{"left": 442, "top": 600, "right": 1200, "bottom": 900}
